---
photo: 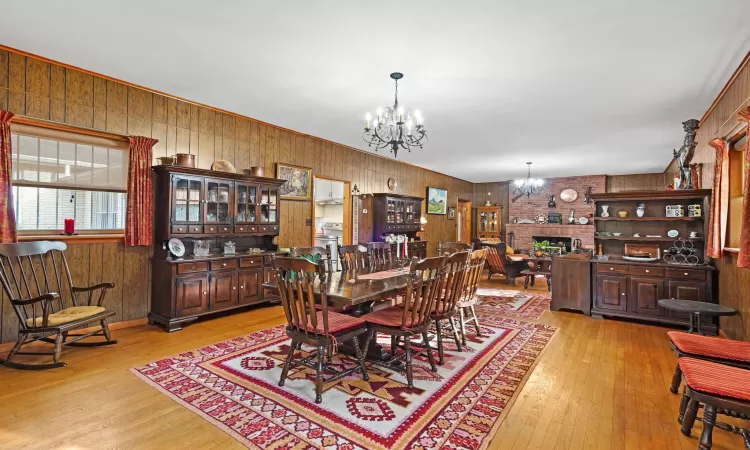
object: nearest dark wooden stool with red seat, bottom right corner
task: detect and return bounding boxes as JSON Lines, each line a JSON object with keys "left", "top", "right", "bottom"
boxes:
{"left": 679, "top": 357, "right": 750, "bottom": 450}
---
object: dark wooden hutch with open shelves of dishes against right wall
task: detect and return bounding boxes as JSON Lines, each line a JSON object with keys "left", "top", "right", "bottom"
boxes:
{"left": 592, "top": 190, "right": 716, "bottom": 330}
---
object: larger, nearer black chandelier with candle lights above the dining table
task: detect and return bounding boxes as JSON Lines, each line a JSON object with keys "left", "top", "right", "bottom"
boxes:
{"left": 362, "top": 72, "right": 427, "bottom": 158}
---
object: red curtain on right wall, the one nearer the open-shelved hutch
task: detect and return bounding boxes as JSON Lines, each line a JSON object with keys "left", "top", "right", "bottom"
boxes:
{"left": 706, "top": 139, "right": 729, "bottom": 258}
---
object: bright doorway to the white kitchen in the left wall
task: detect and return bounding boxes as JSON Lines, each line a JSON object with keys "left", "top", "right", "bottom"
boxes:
{"left": 311, "top": 175, "right": 352, "bottom": 270}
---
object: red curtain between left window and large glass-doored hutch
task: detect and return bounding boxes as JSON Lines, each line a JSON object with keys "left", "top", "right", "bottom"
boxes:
{"left": 125, "top": 136, "right": 159, "bottom": 247}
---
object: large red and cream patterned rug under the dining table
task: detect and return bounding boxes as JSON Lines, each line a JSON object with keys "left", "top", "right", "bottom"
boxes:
{"left": 131, "top": 313, "right": 556, "bottom": 450}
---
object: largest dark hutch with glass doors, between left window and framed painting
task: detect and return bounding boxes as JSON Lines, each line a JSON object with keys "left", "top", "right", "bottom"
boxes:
{"left": 149, "top": 166, "right": 283, "bottom": 331}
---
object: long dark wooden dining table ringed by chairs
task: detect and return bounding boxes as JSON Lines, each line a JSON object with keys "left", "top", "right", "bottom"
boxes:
{"left": 263, "top": 265, "right": 418, "bottom": 361}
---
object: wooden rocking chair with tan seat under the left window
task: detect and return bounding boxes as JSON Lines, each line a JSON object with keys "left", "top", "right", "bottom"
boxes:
{"left": 0, "top": 241, "right": 117, "bottom": 370}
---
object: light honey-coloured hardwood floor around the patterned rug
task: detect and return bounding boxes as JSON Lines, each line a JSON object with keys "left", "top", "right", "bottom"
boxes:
{"left": 0, "top": 279, "right": 742, "bottom": 450}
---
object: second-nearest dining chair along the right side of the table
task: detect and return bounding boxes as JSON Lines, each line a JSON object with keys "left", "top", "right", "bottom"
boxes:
{"left": 430, "top": 251, "right": 470, "bottom": 366}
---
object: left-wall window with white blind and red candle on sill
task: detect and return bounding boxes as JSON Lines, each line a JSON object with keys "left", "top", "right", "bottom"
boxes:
{"left": 11, "top": 125, "right": 128, "bottom": 232}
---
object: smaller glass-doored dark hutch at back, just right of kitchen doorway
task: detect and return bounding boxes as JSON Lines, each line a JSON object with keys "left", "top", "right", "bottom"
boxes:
{"left": 359, "top": 193, "right": 427, "bottom": 258}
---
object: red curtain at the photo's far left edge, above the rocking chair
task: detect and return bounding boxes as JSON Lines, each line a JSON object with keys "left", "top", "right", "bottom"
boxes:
{"left": 0, "top": 109, "right": 17, "bottom": 243}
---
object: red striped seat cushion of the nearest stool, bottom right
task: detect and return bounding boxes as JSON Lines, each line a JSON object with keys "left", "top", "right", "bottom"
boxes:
{"left": 679, "top": 357, "right": 750, "bottom": 401}
